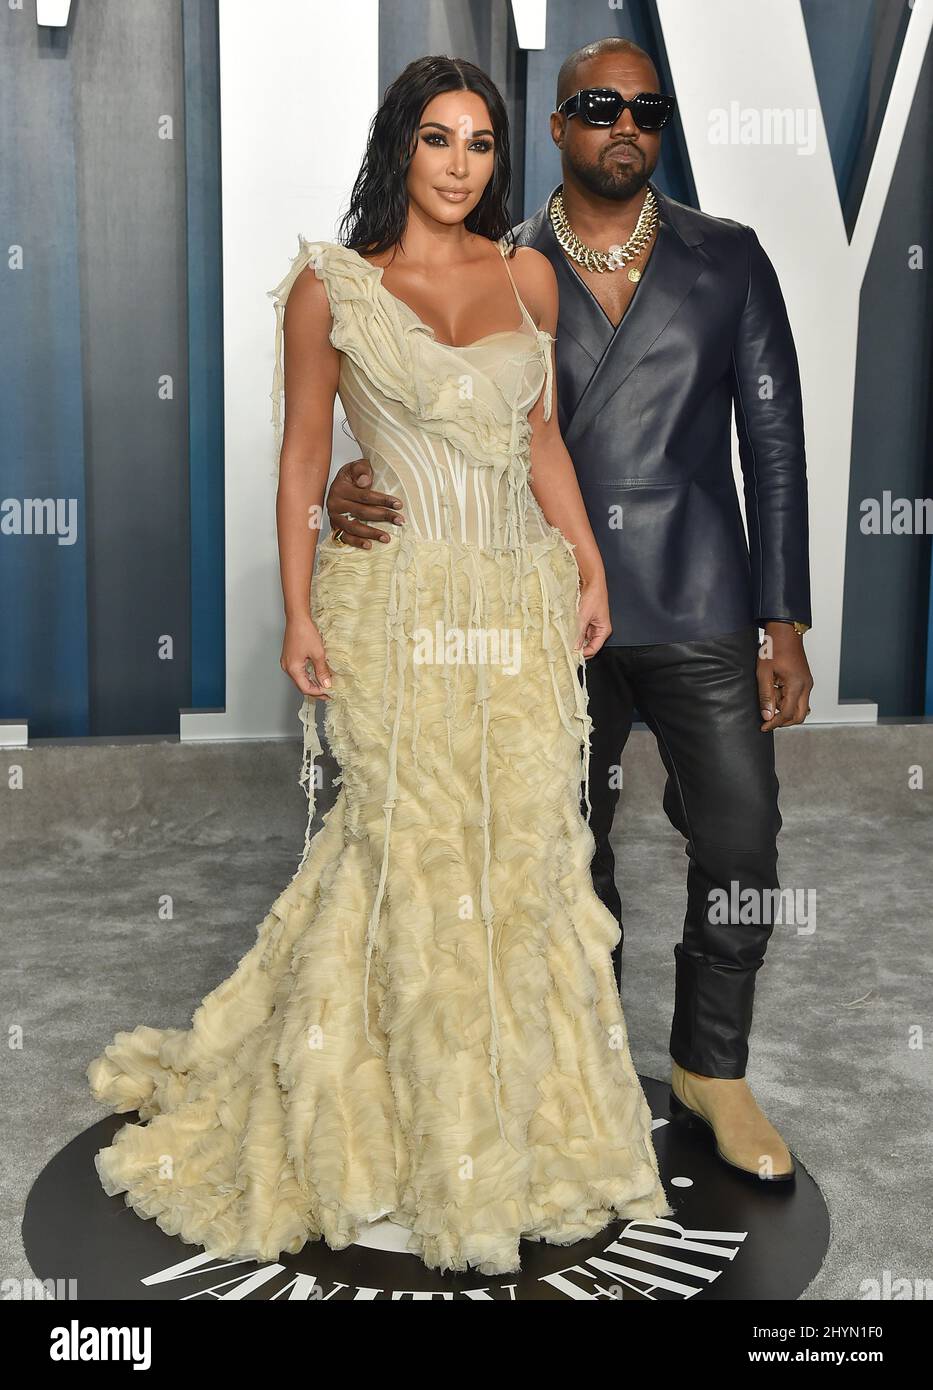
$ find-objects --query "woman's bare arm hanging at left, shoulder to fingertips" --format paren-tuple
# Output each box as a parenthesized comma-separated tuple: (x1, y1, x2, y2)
(275, 267, 339, 698)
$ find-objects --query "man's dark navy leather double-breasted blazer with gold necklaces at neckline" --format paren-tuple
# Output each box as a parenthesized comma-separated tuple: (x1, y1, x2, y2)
(514, 185, 811, 646)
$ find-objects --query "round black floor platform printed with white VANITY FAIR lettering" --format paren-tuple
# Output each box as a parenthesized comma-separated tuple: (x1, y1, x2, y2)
(22, 1077, 829, 1302)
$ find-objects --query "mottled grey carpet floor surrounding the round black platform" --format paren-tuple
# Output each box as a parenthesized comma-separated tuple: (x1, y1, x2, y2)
(0, 723, 933, 1300)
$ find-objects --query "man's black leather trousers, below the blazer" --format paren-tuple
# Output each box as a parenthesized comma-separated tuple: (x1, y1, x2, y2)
(587, 626, 781, 1077)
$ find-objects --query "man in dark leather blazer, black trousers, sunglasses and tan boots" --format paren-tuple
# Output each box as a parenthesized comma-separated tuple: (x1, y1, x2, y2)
(328, 39, 812, 1182)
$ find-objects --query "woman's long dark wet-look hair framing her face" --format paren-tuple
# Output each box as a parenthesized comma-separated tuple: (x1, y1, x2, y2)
(339, 57, 512, 256)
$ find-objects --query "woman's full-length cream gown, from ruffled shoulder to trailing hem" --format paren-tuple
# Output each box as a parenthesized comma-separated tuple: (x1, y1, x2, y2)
(88, 60, 672, 1275)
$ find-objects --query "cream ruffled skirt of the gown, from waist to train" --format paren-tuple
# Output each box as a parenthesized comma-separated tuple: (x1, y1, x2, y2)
(88, 537, 672, 1275)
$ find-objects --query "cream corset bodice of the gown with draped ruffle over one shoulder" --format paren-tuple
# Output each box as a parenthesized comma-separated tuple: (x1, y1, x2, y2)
(270, 236, 553, 552)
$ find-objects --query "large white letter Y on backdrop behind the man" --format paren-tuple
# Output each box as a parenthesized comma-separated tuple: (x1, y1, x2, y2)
(658, 0, 933, 721)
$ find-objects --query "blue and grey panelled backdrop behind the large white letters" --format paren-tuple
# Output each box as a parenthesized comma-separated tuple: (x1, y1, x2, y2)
(0, 0, 933, 738)
